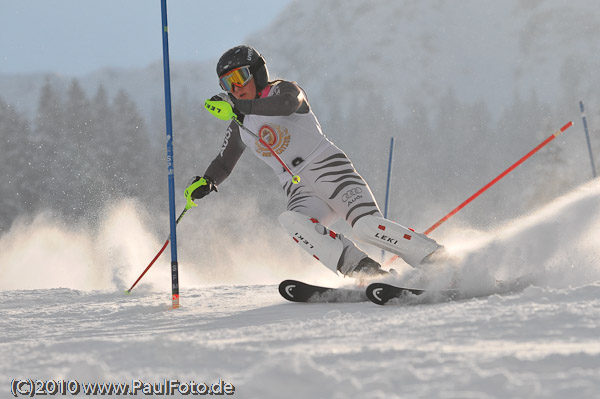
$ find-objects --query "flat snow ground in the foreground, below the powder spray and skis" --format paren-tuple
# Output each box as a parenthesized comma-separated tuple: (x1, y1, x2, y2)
(2, 284, 600, 398)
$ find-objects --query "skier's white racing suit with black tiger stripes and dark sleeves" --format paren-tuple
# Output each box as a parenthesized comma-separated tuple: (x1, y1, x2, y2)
(205, 81, 439, 274)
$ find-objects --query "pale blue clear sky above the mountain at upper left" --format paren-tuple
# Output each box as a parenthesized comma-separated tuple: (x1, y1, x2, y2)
(0, 0, 291, 76)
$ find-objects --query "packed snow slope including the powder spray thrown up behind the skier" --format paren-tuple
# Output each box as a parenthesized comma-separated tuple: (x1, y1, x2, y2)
(0, 180, 600, 398)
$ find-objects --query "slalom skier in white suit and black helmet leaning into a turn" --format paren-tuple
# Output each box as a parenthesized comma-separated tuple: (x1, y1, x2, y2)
(186, 45, 441, 277)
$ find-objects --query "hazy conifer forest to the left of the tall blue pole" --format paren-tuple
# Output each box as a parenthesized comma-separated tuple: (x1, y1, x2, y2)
(0, 79, 158, 232)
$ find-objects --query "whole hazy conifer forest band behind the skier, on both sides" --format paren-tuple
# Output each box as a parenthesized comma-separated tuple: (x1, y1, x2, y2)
(0, 72, 600, 238)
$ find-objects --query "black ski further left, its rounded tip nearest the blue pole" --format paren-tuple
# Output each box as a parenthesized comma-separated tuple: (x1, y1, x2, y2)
(279, 280, 367, 303)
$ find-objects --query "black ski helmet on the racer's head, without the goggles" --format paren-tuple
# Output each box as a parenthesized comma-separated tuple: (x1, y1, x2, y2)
(217, 45, 269, 92)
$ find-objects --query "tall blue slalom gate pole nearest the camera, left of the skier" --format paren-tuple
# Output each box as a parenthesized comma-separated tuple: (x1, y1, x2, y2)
(161, 0, 179, 309)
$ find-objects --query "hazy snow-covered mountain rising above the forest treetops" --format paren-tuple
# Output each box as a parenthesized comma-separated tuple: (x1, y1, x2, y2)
(5, 0, 600, 119)
